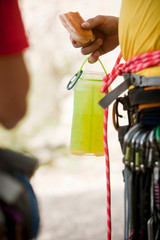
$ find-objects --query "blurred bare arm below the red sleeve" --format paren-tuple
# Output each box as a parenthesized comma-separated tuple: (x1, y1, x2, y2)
(0, 53, 29, 129)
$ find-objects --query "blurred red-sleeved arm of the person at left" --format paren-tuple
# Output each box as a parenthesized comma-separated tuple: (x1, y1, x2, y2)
(0, 0, 29, 129)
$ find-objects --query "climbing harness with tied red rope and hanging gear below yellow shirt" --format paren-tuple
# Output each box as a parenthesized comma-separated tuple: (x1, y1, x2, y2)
(99, 50, 160, 240)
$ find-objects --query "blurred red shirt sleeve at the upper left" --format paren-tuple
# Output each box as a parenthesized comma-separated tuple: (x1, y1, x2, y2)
(0, 0, 28, 55)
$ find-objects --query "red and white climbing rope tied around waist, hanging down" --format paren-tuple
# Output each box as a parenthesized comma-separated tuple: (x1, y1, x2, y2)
(101, 50, 160, 240)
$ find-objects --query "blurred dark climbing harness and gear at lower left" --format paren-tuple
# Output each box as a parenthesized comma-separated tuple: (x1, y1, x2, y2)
(0, 148, 40, 240)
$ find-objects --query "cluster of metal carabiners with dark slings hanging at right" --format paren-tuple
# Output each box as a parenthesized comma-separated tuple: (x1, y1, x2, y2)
(123, 123, 160, 240)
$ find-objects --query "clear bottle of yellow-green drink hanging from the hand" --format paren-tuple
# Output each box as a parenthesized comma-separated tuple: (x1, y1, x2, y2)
(67, 57, 106, 156)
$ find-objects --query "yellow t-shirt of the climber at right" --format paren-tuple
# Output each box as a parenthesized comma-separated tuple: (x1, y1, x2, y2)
(119, 0, 160, 76)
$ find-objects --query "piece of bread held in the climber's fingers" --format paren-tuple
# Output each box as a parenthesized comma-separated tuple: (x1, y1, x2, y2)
(59, 12, 95, 45)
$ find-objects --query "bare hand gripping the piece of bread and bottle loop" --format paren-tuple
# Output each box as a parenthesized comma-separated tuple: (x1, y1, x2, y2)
(71, 15, 119, 63)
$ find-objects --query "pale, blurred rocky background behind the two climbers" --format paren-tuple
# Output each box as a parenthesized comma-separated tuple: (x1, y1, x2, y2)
(0, 0, 123, 240)
